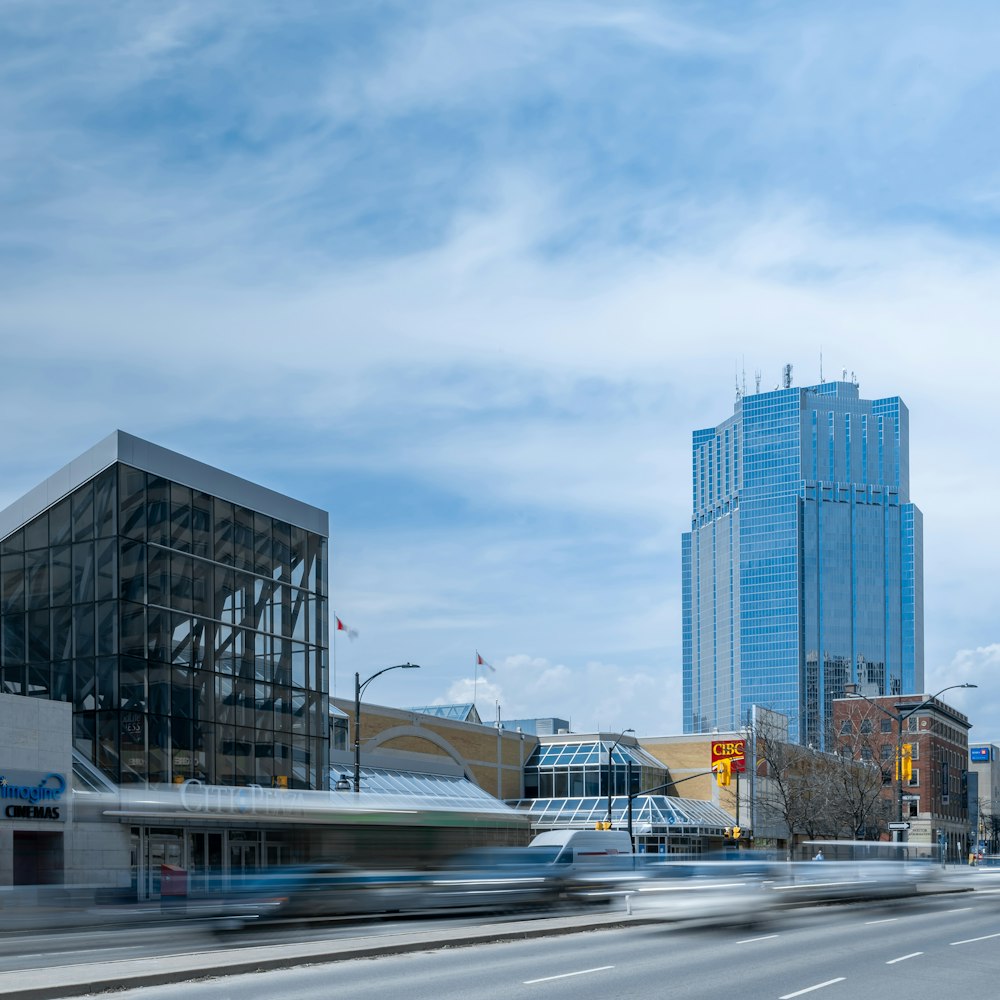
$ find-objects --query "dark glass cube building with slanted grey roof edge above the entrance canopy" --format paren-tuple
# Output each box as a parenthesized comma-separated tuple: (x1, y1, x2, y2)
(0, 431, 329, 789)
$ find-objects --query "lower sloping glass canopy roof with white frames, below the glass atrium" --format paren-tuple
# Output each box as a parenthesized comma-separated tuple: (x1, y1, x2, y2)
(508, 795, 733, 834)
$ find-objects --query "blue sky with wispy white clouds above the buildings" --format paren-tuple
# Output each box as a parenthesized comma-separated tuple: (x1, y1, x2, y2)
(0, 0, 1000, 739)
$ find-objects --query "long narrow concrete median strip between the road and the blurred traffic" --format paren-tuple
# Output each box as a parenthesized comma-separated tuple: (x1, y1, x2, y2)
(0, 907, 657, 1000)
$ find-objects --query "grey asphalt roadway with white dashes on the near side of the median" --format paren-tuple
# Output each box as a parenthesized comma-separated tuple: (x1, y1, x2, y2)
(45, 891, 1000, 1000)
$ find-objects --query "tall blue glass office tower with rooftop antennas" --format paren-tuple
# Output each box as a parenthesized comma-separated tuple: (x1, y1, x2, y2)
(682, 382, 923, 746)
